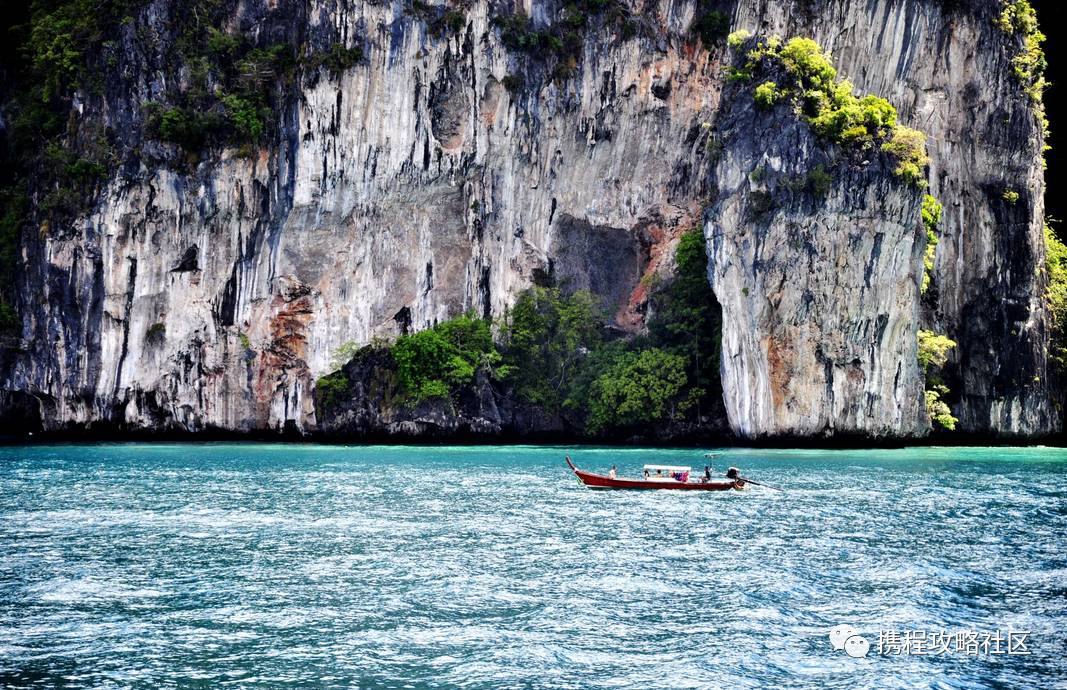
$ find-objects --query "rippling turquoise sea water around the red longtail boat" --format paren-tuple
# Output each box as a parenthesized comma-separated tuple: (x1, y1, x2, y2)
(0, 445, 1067, 689)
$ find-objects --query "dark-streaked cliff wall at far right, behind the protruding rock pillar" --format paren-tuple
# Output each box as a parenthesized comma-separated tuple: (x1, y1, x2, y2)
(734, 0, 1058, 435)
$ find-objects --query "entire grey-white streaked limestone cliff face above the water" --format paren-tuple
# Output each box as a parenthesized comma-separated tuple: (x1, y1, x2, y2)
(0, 0, 1056, 436)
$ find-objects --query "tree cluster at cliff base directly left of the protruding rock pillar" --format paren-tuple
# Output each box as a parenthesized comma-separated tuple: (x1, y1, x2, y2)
(503, 228, 721, 435)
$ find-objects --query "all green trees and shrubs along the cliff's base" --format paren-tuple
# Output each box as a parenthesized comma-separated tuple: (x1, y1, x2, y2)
(316, 229, 720, 435)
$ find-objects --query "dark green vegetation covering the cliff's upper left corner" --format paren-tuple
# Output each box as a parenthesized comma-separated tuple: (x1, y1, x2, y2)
(0, 0, 375, 332)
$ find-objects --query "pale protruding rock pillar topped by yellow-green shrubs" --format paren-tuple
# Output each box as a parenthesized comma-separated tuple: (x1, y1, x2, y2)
(704, 94, 927, 436)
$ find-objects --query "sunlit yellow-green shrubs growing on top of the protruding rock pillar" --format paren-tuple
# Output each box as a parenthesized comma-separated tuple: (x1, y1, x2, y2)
(728, 32, 929, 187)
